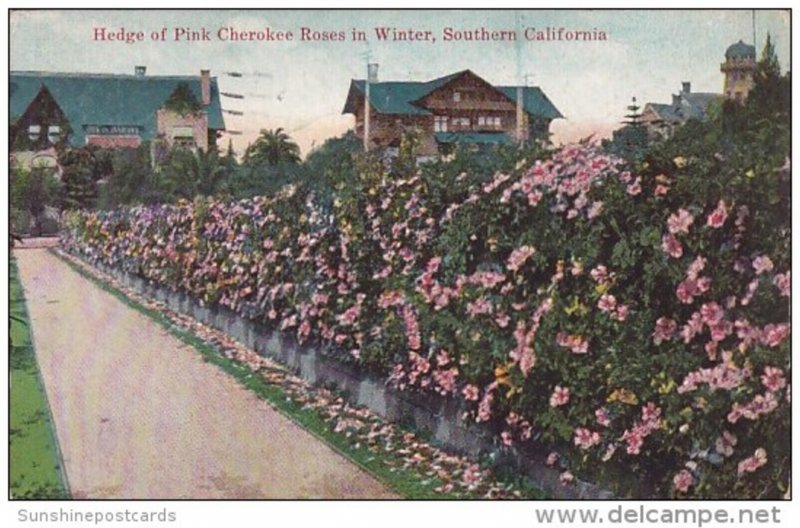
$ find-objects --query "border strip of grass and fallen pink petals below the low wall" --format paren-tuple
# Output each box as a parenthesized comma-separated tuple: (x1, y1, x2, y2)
(55, 250, 544, 499)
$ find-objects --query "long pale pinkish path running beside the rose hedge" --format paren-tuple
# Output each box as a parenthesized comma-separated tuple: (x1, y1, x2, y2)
(14, 249, 396, 499)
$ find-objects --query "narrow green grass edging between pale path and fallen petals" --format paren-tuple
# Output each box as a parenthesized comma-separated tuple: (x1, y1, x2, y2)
(51, 250, 545, 500)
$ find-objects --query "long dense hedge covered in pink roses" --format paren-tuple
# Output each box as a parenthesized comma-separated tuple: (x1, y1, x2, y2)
(62, 145, 791, 498)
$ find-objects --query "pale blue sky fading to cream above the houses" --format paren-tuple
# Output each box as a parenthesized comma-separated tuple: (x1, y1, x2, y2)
(9, 9, 790, 154)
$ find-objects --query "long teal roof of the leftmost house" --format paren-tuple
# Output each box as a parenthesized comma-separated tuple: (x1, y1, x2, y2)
(9, 72, 225, 146)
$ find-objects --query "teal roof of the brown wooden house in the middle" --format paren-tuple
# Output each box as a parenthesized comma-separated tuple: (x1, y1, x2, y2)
(342, 70, 564, 119)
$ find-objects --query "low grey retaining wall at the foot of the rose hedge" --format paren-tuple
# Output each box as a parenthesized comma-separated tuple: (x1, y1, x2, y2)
(76, 254, 613, 499)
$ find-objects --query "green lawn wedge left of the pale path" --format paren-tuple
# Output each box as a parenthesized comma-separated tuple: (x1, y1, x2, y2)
(9, 260, 68, 499)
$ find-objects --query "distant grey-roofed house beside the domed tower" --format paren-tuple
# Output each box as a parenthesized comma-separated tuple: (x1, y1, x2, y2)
(641, 82, 722, 140)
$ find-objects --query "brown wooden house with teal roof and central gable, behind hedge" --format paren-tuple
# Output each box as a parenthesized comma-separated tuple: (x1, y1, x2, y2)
(342, 70, 563, 156)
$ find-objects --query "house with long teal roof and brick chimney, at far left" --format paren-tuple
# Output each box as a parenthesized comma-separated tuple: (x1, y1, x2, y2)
(9, 66, 225, 157)
